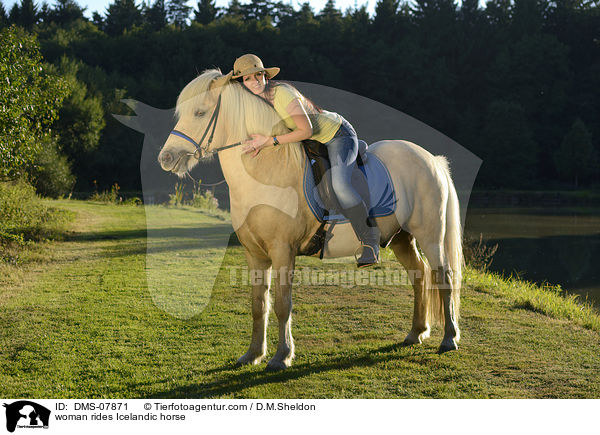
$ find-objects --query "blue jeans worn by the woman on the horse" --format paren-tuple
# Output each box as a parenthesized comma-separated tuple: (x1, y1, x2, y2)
(325, 118, 362, 209)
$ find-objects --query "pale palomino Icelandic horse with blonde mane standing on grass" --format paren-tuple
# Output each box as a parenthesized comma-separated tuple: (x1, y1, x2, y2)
(158, 70, 463, 369)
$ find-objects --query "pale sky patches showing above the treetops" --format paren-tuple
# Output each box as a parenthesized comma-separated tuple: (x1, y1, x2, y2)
(0, 0, 377, 18)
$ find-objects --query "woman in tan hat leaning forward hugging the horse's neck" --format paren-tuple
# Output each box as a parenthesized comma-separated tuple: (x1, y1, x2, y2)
(232, 54, 379, 267)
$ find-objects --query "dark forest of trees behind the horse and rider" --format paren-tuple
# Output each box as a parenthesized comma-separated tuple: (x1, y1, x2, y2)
(0, 0, 600, 197)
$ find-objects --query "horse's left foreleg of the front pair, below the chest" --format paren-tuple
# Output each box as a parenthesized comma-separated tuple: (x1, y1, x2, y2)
(237, 252, 271, 366)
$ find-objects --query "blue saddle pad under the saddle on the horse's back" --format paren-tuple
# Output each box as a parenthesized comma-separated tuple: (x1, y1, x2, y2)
(304, 153, 396, 223)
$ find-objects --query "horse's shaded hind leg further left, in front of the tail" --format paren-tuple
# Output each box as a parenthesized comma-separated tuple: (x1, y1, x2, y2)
(390, 231, 431, 346)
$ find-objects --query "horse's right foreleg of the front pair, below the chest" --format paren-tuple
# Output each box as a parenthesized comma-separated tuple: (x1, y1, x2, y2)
(267, 246, 295, 370)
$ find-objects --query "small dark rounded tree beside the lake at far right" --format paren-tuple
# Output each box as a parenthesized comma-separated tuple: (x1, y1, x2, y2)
(554, 118, 596, 186)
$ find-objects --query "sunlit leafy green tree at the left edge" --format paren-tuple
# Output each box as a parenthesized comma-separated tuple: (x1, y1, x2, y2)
(0, 26, 68, 180)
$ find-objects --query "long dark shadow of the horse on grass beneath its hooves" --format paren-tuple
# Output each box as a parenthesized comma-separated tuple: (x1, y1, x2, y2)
(152, 343, 422, 399)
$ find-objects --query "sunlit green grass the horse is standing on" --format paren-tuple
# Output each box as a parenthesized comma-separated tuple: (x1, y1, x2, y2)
(0, 201, 600, 398)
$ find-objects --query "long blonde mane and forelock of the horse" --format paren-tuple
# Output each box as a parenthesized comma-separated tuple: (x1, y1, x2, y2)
(175, 69, 304, 171)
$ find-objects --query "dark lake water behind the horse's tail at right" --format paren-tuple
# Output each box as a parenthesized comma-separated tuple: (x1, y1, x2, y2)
(465, 207, 600, 310)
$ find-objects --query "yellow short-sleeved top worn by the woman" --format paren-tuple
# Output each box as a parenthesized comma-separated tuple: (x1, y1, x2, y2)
(273, 84, 342, 143)
